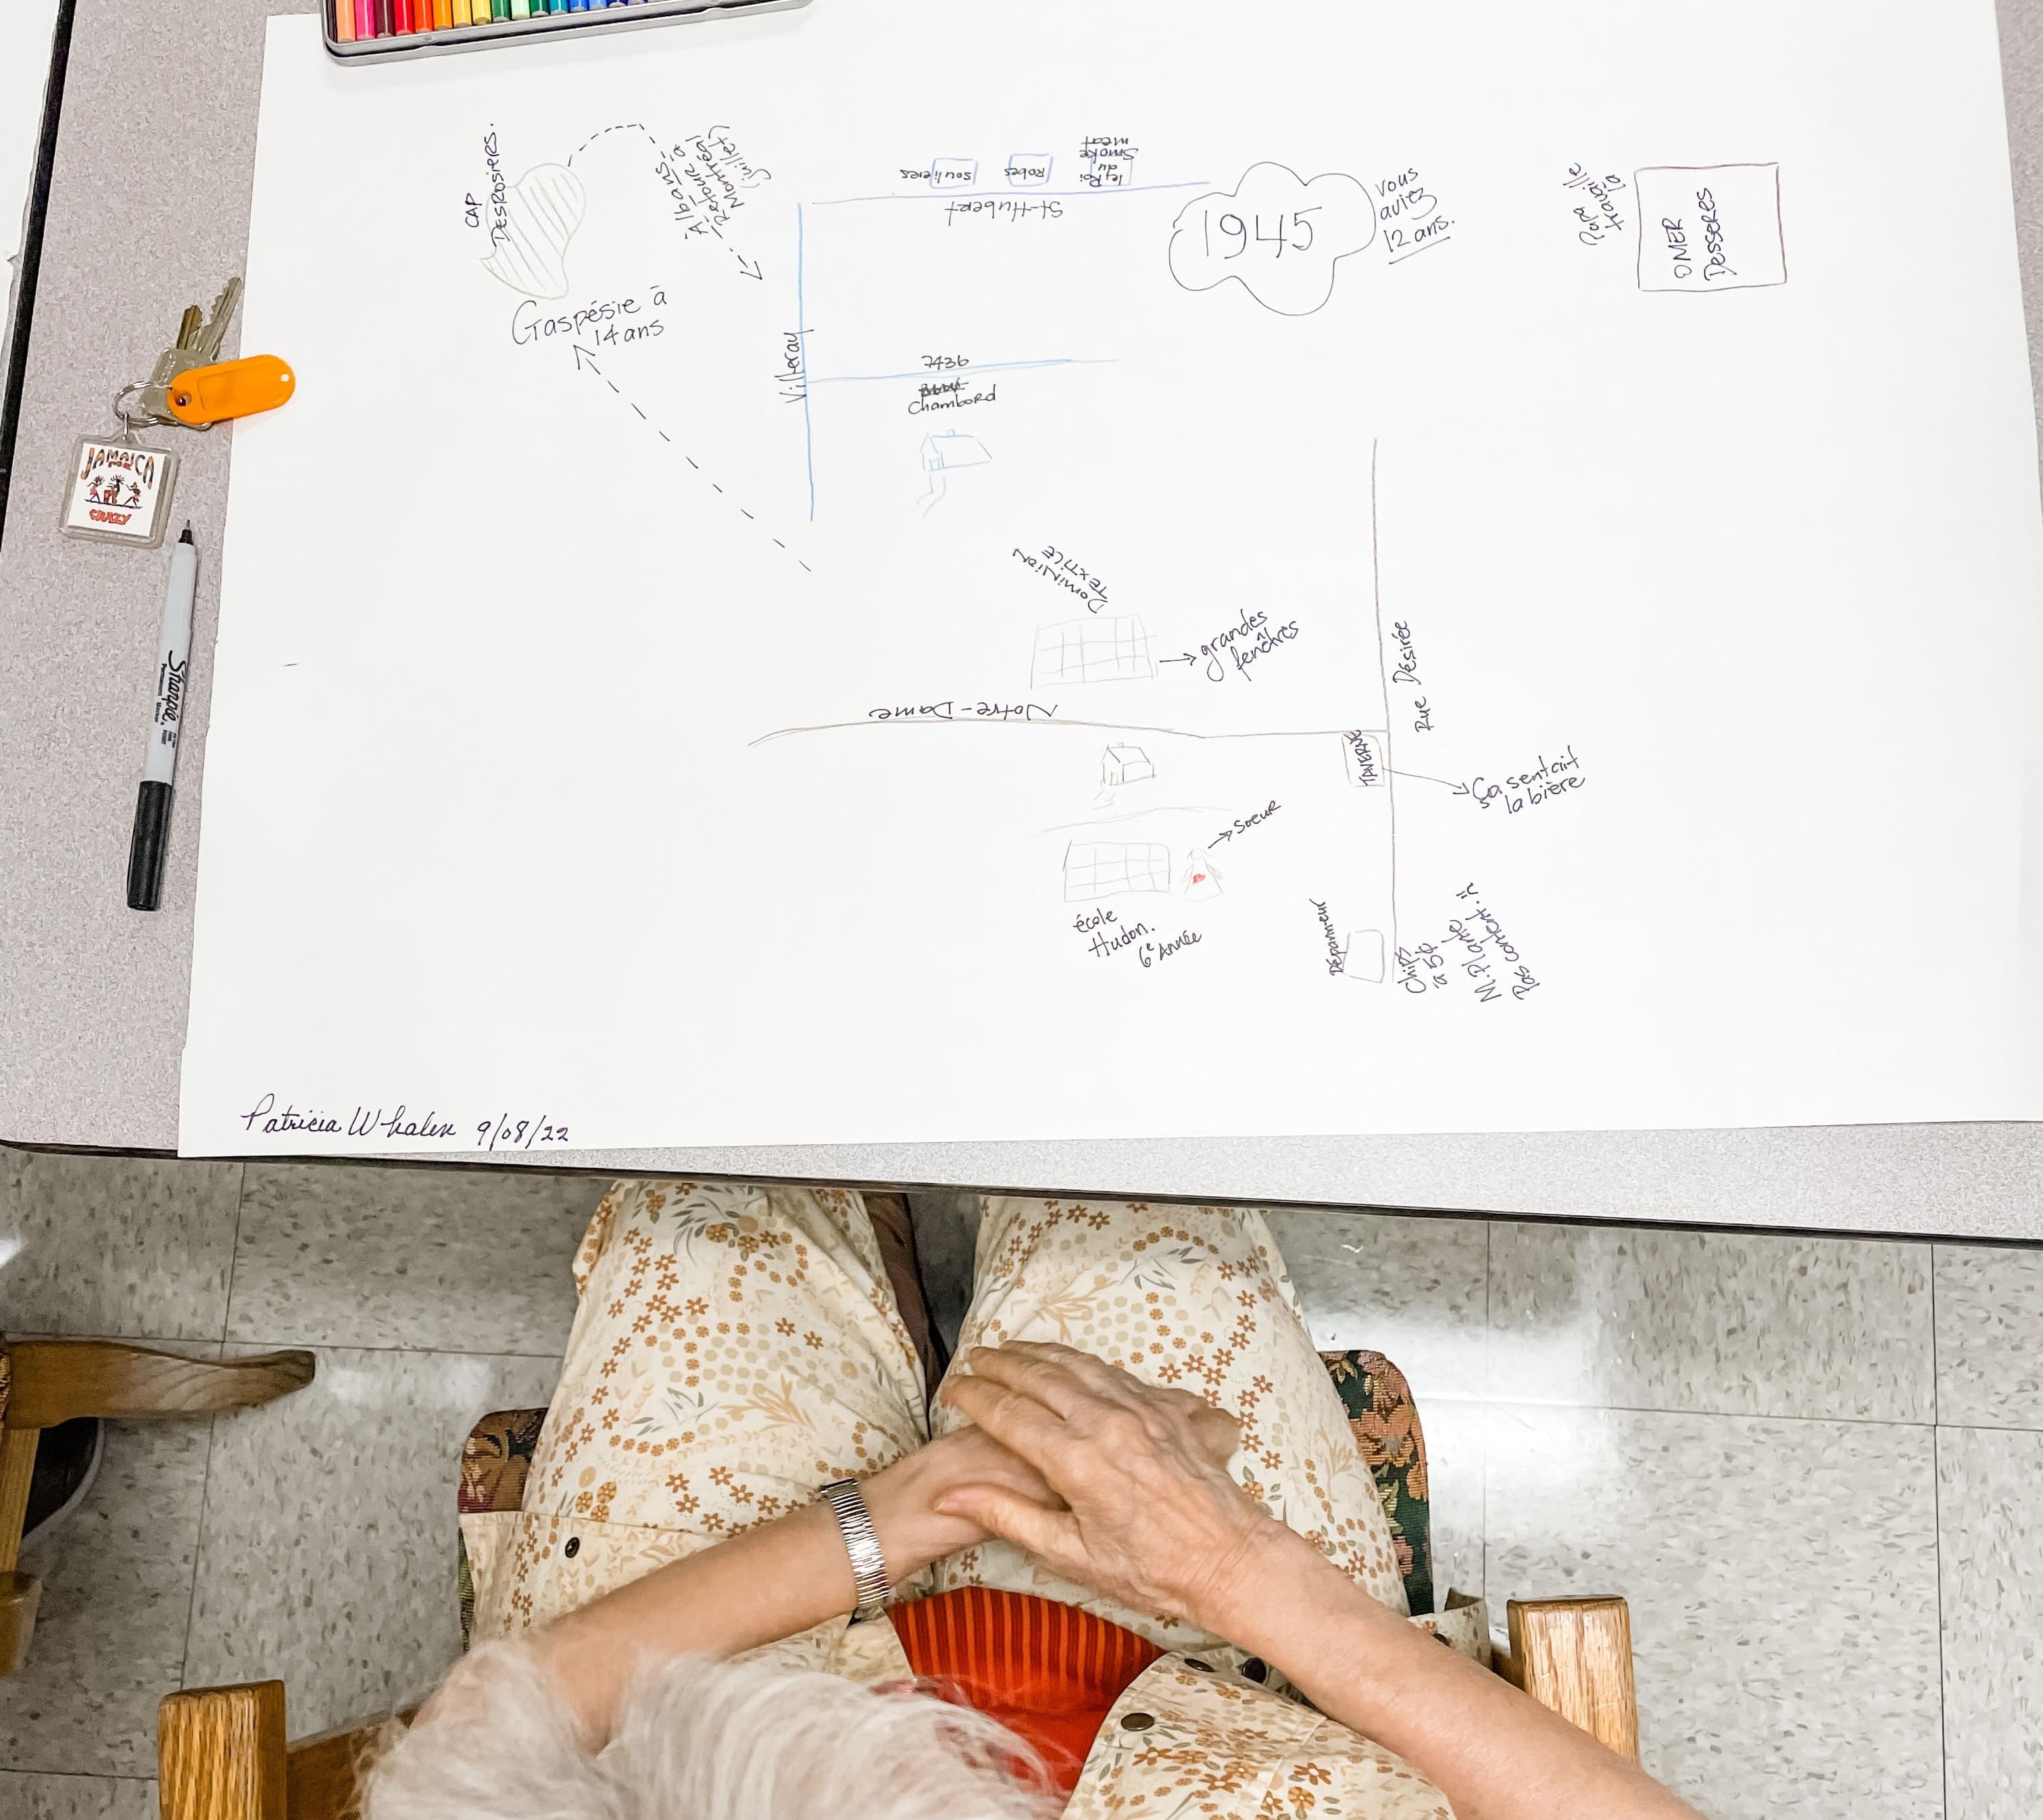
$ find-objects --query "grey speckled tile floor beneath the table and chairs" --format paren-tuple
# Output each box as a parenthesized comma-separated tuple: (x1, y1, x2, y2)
(0, 1152, 2043, 1820)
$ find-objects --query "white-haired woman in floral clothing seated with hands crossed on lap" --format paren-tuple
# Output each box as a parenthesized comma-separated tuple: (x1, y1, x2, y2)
(366, 1183, 1694, 1820)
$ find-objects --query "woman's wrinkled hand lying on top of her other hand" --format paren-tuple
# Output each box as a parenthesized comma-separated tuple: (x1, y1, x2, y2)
(936, 1342, 1324, 1634)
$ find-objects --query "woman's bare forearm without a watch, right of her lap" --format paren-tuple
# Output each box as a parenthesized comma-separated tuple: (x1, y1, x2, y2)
(1214, 1544, 1698, 1820)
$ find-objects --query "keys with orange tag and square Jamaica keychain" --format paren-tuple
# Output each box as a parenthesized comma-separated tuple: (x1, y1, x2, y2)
(57, 278, 298, 549)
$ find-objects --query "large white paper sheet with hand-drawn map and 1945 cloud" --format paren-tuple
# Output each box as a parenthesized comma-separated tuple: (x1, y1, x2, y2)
(182, 0, 2043, 1154)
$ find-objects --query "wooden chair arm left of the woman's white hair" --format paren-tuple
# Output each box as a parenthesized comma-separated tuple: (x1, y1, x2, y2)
(155, 1681, 390, 1820)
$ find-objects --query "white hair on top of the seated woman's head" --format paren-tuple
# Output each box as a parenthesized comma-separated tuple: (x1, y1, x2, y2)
(362, 1640, 1064, 1820)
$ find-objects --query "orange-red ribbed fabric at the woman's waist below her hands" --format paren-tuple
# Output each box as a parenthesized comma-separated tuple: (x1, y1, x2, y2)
(889, 1587, 1162, 1794)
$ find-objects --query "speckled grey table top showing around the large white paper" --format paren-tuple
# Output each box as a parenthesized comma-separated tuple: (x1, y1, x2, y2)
(0, 0, 2043, 1240)
